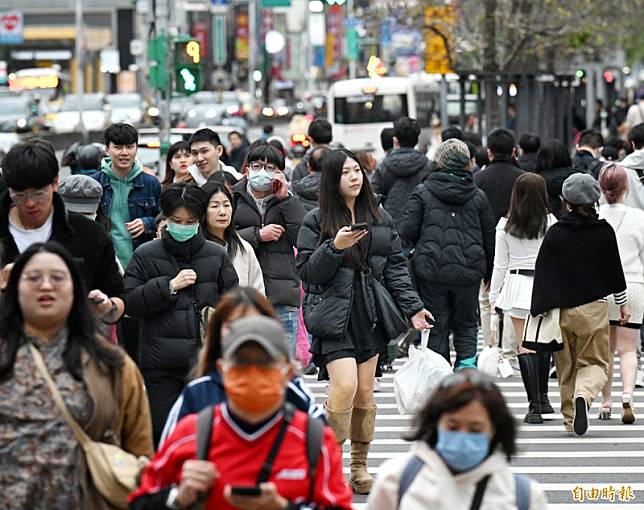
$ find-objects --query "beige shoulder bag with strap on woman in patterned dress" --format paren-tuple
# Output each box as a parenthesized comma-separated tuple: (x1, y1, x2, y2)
(29, 343, 141, 509)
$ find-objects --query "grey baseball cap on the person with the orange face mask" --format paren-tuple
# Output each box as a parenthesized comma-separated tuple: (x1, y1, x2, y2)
(222, 315, 291, 361)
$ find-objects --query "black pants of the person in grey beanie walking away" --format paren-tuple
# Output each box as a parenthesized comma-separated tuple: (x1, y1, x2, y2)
(417, 279, 479, 368)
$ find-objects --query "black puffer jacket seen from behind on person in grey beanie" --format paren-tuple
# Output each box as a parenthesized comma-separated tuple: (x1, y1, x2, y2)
(400, 170, 495, 285)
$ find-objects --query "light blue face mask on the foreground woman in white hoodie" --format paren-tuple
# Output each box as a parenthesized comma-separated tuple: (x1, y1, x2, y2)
(434, 428, 490, 471)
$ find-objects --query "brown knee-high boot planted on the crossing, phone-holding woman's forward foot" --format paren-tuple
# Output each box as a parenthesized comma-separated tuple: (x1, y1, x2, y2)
(349, 404, 376, 494)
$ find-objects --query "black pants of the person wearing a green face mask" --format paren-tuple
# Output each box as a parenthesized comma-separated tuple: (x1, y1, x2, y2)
(141, 369, 188, 449)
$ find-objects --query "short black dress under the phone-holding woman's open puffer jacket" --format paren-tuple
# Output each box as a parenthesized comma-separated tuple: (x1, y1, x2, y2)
(311, 271, 387, 381)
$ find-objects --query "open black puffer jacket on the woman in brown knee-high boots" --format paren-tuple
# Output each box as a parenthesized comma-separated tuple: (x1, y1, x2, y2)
(297, 205, 423, 338)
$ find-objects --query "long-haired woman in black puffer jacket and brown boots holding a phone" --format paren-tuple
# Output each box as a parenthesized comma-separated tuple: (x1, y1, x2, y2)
(297, 149, 432, 494)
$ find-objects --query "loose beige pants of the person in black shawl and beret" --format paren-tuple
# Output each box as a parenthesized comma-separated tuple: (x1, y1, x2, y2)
(555, 301, 610, 431)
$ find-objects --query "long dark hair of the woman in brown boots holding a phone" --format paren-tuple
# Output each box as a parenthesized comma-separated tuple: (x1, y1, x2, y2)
(320, 149, 380, 267)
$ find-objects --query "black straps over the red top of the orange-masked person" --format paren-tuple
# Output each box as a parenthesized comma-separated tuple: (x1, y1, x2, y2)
(196, 402, 324, 502)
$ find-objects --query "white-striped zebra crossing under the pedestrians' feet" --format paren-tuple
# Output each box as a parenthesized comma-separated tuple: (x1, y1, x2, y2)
(307, 352, 644, 510)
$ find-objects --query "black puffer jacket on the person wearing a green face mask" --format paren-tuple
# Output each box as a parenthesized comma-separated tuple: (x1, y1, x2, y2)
(125, 232, 238, 370)
